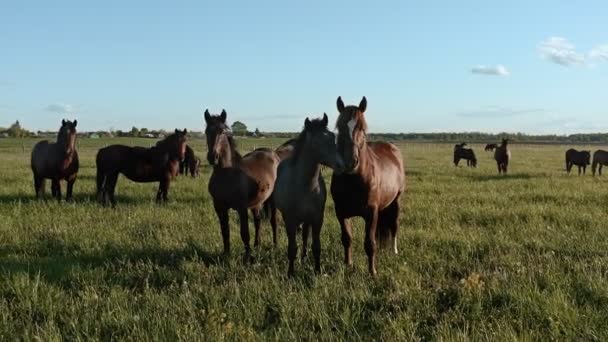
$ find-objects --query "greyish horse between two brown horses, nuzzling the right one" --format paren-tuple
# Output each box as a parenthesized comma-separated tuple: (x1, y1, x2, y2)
(273, 113, 342, 276)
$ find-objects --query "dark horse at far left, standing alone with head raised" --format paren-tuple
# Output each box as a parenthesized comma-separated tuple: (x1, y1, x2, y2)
(31, 120, 79, 201)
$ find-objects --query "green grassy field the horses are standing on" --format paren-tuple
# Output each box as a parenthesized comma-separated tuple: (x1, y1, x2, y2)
(0, 139, 608, 341)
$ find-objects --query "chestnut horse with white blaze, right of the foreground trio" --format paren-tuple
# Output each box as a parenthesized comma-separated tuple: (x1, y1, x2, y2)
(331, 97, 405, 276)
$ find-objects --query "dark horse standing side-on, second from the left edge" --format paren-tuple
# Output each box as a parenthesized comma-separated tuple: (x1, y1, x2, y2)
(96, 129, 188, 207)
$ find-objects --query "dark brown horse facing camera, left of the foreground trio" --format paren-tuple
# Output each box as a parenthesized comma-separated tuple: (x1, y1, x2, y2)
(205, 110, 280, 262)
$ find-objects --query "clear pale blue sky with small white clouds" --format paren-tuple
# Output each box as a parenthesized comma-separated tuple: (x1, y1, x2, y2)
(0, 0, 608, 134)
